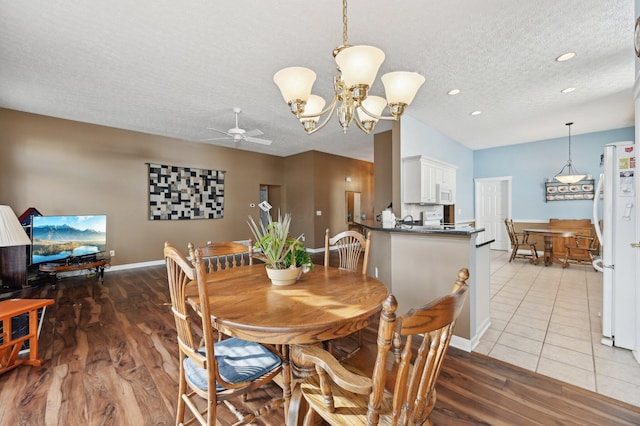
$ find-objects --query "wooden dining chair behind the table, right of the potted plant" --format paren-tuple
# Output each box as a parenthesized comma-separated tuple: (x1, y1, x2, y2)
(324, 228, 371, 358)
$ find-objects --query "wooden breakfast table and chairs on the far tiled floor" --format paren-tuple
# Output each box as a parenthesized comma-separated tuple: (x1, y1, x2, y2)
(505, 218, 600, 268)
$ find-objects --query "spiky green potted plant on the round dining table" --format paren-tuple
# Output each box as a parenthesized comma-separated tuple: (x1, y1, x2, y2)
(247, 212, 313, 285)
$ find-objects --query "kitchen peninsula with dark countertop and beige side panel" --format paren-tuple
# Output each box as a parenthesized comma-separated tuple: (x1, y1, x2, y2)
(359, 221, 493, 351)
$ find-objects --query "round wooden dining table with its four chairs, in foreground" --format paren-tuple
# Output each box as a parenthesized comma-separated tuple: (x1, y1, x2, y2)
(164, 231, 468, 425)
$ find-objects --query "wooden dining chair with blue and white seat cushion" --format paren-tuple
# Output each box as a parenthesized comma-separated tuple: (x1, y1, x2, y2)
(164, 242, 284, 425)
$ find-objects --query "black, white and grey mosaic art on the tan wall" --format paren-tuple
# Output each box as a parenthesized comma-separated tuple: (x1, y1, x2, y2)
(148, 164, 225, 220)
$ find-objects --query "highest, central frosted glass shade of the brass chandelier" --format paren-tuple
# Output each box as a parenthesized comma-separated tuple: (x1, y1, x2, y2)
(336, 46, 384, 88)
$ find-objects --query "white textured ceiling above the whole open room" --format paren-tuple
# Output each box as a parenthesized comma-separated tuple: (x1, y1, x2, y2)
(0, 0, 635, 161)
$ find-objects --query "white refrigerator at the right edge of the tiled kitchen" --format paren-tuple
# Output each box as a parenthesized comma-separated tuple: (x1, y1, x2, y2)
(593, 142, 640, 350)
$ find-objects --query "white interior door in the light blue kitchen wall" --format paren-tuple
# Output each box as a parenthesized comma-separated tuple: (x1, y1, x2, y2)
(475, 177, 511, 250)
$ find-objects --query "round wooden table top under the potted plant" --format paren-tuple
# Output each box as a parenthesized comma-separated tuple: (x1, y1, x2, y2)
(182, 264, 388, 344)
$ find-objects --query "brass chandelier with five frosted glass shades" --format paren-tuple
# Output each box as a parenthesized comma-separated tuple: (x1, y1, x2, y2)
(273, 0, 424, 134)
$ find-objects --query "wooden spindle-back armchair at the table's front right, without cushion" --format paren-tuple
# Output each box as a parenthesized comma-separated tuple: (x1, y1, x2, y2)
(288, 268, 469, 426)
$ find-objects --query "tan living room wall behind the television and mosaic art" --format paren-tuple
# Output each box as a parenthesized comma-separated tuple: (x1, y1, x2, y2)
(0, 108, 373, 265)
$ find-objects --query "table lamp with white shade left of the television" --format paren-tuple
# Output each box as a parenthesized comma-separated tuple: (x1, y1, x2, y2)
(0, 206, 31, 288)
